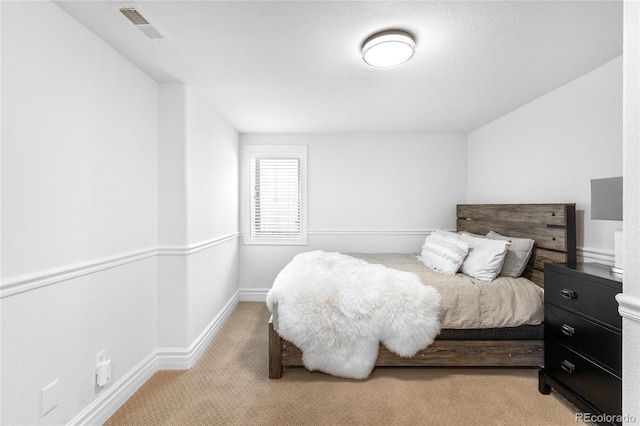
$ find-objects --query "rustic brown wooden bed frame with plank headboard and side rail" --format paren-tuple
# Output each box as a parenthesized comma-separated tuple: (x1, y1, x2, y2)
(269, 204, 576, 379)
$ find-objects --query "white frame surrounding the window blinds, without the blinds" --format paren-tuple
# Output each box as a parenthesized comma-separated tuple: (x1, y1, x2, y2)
(242, 145, 307, 246)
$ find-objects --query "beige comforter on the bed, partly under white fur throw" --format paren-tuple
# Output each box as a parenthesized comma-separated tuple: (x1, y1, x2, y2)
(350, 253, 544, 329)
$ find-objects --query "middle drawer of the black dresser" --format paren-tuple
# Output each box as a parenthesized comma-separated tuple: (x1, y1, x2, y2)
(544, 305, 622, 375)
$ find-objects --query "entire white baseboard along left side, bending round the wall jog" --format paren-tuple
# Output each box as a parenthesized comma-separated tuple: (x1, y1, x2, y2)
(68, 291, 240, 425)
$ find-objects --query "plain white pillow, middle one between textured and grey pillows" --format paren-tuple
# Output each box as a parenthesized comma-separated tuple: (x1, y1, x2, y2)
(460, 234, 511, 281)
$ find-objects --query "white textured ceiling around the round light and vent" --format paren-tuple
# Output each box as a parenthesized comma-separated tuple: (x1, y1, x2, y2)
(56, 1, 622, 133)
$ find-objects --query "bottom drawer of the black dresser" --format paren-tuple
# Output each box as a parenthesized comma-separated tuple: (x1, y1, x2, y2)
(544, 340, 622, 415)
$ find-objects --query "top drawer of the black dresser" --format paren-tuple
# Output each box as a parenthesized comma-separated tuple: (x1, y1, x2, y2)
(544, 271, 622, 329)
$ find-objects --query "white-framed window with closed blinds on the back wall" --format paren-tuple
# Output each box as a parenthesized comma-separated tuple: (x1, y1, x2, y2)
(243, 145, 307, 245)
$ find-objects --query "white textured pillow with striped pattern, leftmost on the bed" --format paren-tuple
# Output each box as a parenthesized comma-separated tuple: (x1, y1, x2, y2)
(420, 233, 469, 275)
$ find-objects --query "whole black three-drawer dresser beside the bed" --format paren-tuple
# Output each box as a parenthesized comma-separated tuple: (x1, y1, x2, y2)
(539, 263, 622, 424)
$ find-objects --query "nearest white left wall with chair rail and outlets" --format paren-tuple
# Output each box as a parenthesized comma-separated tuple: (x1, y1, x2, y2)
(1, 2, 158, 424)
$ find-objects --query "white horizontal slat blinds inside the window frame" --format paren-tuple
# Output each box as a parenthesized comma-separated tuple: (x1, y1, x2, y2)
(250, 158, 302, 239)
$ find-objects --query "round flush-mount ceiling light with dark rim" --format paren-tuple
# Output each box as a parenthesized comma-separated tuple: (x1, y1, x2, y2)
(362, 30, 416, 68)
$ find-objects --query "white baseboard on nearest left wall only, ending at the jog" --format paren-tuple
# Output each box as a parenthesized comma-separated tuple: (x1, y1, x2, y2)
(68, 351, 158, 425)
